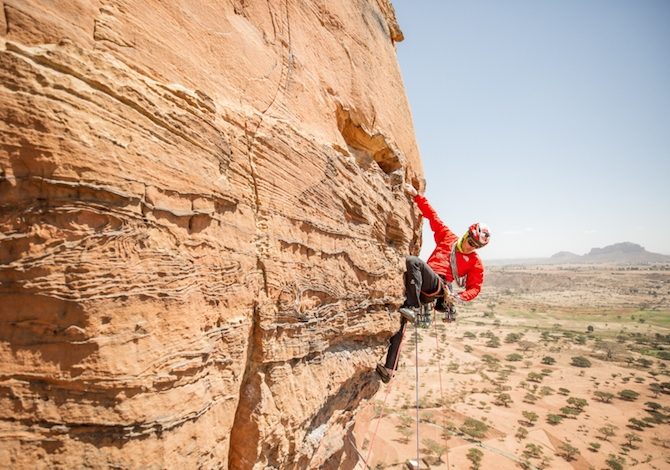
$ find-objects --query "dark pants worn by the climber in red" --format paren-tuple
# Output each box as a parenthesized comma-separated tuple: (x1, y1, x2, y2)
(385, 256, 442, 370)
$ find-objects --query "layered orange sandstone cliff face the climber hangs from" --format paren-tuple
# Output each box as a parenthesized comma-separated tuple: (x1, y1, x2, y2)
(0, 0, 423, 469)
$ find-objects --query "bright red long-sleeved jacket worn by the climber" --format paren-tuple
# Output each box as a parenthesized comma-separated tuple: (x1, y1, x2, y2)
(414, 194, 484, 301)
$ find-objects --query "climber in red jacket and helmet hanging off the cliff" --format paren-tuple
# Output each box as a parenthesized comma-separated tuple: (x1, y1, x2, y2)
(377, 184, 490, 383)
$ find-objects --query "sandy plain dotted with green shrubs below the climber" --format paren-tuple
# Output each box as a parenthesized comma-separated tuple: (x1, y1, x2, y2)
(353, 266, 670, 470)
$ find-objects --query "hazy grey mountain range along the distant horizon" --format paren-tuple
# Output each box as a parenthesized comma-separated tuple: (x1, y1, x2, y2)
(486, 242, 670, 266)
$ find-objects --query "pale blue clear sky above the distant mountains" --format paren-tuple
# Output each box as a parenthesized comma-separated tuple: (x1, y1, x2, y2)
(393, 0, 670, 260)
